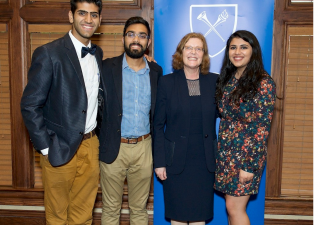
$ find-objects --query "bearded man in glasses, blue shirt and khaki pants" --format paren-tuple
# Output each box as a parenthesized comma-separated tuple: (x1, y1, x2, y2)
(99, 17, 162, 225)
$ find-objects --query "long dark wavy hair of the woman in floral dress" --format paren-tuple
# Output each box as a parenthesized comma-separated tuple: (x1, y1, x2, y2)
(216, 30, 272, 105)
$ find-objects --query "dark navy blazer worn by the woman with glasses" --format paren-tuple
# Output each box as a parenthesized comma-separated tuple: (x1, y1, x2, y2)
(153, 70, 218, 174)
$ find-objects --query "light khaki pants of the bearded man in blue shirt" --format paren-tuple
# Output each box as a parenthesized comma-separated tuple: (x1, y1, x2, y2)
(100, 136, 152, 225)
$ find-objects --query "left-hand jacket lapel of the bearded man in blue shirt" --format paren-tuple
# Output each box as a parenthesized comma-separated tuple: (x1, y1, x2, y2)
(112, 54, 123, 109)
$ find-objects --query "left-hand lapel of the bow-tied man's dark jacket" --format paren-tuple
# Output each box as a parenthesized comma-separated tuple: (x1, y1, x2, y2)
(64, 33, 86, 90)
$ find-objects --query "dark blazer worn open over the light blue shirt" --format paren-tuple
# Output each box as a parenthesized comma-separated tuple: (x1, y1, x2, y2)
(99, 54, 163, 163)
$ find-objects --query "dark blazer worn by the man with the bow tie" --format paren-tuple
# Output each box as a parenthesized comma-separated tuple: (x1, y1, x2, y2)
(21, 34, 103, 166)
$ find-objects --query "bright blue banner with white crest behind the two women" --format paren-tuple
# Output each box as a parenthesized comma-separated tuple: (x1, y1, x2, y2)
(153, 0, 274, 225)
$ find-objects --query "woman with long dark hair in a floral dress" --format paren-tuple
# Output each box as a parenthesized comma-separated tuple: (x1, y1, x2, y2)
(214, 30, 276, 225)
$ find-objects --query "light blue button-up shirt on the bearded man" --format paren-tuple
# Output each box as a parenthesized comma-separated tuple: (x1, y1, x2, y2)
(121, 54, 151, 138)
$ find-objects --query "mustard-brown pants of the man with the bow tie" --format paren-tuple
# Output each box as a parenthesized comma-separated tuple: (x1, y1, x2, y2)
(40, 136, 99, 225)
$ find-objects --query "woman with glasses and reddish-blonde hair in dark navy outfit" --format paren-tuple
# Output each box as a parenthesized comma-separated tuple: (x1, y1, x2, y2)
(153, 33, 218, 225)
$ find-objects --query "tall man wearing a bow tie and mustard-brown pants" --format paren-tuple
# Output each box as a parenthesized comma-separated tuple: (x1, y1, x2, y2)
(21, 0, 103, 225)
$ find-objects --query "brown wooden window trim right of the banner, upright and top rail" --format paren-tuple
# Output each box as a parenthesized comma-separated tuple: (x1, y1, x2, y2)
(266, 0, 313, 197)
